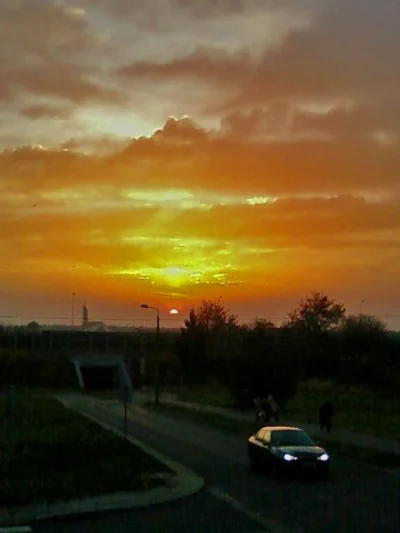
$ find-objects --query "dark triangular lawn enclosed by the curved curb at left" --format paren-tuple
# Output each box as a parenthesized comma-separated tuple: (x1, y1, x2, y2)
(0, 386, 173, 507)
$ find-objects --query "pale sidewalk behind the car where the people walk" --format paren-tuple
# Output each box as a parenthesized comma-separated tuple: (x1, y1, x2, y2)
(150, 393, 400, 458)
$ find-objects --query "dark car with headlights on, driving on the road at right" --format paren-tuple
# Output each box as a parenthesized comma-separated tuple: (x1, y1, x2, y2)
(248, 426, 330, 478)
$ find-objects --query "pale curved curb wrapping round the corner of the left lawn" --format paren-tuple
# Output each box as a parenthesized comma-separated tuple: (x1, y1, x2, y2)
(0, 398, 204, 533)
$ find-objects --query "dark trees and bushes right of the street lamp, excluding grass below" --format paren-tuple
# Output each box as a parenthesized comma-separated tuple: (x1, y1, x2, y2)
(175, 292, 400, 403)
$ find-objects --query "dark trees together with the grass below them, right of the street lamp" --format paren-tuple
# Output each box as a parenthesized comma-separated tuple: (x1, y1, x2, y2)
(160, 293, 400, 440)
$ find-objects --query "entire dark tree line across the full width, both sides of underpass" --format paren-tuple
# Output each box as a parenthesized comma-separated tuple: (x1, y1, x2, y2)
(0, 293, 400, 404)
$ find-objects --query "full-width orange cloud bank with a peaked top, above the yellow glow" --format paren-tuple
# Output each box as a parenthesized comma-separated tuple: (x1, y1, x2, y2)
(0, 119, 400, 196)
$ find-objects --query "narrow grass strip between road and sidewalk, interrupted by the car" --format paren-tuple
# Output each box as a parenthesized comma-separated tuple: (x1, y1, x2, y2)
(144, 403, 400, 468)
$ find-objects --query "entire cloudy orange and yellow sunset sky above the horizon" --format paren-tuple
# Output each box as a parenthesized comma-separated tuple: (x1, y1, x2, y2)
(0, 0, 400, 328)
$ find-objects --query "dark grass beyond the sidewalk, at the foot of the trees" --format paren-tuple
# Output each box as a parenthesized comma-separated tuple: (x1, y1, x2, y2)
(165, 381, 400, 440)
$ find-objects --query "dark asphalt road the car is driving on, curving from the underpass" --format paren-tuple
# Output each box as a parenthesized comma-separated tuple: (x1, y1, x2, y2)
(34, 400, 400, 533)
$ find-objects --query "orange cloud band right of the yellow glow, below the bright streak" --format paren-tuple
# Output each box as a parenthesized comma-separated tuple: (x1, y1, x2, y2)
(166, 196, 400, 247)
